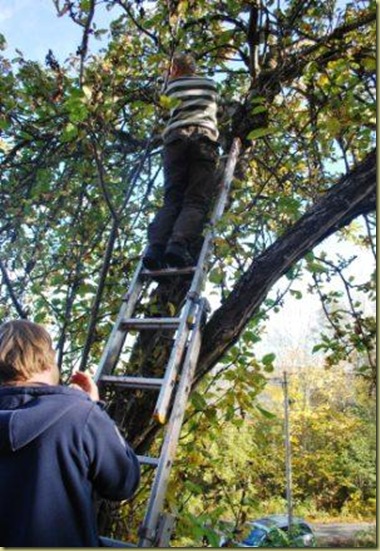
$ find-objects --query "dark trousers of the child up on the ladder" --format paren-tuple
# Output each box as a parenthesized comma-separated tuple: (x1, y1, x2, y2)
(148, 126, 218, 254)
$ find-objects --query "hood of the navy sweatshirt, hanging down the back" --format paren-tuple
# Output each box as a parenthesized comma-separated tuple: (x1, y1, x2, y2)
(0, 385, 91, 453)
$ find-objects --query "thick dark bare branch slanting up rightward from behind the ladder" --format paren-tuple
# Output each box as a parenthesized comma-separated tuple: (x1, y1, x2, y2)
(196, 150, 376, 382)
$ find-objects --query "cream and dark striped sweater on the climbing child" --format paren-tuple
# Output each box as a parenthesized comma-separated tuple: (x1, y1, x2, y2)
(163, 76, 219, 140)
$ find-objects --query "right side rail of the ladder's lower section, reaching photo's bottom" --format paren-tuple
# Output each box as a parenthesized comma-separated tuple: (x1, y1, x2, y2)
(139, 300, 205, 547)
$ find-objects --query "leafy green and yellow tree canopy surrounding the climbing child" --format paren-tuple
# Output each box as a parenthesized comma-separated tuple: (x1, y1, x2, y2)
(0, 0, 376, 540)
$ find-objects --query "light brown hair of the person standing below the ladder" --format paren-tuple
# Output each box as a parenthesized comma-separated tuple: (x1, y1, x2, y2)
(0, 320, 56, 384)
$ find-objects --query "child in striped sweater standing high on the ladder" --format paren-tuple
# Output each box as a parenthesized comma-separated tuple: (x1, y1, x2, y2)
(143, 54, 219, 270)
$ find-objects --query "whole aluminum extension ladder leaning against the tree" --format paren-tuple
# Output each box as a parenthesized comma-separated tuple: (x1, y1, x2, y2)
(94, 138, 241, 547)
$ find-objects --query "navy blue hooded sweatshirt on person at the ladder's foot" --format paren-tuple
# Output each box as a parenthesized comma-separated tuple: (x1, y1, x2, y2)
(0, 385, 140, 547)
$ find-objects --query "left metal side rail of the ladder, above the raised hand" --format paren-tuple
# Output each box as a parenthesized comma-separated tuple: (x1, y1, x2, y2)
(94, 259, 143, 382)
